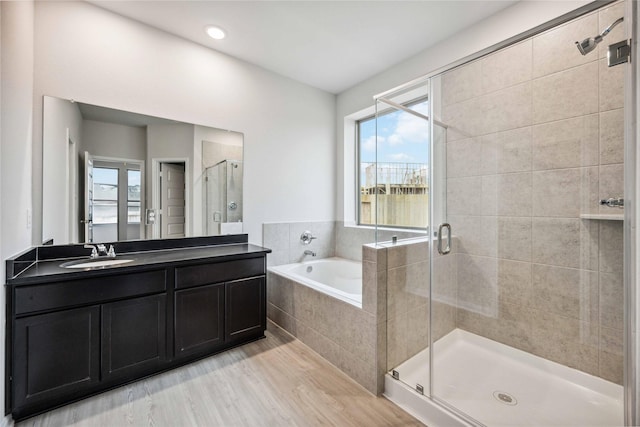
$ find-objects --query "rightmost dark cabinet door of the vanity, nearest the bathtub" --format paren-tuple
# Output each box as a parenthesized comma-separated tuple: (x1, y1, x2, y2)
(226, 277, 267, 341)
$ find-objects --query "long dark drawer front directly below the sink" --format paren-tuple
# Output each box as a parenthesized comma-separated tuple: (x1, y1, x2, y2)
(15, 269, 167, 315)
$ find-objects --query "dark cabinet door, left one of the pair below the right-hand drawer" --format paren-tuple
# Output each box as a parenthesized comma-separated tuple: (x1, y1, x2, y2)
(175, 283, 224, 357)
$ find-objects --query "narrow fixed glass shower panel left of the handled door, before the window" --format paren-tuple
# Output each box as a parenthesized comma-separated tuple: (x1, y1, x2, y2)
(376, 82, 432, 402)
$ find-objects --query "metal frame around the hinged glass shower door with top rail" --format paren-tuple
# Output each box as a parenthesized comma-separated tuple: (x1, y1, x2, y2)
(373, 0, 640, 425)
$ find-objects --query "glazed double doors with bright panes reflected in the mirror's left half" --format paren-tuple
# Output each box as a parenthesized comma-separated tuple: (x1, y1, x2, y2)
(83, 153, 145, 242)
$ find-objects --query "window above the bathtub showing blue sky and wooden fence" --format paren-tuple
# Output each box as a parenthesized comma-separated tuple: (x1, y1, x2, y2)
(356, 98, 429, 228)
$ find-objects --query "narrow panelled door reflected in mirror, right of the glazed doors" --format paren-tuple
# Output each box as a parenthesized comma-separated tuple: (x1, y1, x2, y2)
(160, 163, 186, 239)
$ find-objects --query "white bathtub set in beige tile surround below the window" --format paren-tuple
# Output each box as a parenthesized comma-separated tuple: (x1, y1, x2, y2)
(269, 258, 362, 308)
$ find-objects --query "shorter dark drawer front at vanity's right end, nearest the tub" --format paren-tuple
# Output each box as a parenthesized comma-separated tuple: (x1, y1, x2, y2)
(176, 257, 265, 289)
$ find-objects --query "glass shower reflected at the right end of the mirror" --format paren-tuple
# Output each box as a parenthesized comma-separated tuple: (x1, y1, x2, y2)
(205, 159, 242, 235)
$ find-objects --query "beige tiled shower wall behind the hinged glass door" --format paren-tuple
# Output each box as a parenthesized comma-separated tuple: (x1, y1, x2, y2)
(440, 4, 624, 383)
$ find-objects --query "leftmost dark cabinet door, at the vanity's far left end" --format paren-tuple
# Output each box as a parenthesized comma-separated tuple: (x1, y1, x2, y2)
(12, 306, 100, 410)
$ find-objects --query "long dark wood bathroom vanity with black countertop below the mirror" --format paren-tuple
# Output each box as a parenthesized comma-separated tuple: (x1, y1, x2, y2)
(5, 235, 270, 420)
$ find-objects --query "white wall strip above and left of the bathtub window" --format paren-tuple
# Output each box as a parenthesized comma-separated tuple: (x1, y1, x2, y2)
(336, 1, 590, 223)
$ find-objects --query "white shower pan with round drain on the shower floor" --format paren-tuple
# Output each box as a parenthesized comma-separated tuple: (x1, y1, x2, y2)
(385, 329, 624, 427)
